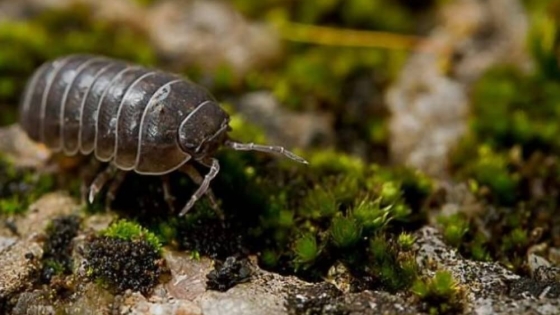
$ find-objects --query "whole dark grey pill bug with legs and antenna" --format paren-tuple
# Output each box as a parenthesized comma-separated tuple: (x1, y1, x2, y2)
(19, 54, 307, 216)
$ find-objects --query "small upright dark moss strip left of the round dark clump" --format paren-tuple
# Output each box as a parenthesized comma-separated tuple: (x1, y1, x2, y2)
(41, 215, 81, 283)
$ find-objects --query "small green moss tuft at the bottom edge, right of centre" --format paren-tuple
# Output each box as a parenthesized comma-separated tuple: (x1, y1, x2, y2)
(411, 270, 465, 315)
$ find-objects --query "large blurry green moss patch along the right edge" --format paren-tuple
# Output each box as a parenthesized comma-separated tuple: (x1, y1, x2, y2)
(440, 1, 560, 275)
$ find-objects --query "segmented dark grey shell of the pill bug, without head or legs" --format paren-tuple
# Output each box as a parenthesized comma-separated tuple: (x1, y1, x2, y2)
(20, 54, 219, 175)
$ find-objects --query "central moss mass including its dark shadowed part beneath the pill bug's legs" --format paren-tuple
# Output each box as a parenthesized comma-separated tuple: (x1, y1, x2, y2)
(112, 130, 432, 290)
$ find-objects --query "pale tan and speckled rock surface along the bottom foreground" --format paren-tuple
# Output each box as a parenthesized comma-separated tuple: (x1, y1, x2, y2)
(0, 183, 560, 315)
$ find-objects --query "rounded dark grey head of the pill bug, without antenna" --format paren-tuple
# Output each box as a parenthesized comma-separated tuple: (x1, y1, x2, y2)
(178, 101, 231, 160)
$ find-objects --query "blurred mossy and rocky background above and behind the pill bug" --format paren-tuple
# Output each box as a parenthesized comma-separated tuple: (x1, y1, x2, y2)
(0, 0, 548, 178)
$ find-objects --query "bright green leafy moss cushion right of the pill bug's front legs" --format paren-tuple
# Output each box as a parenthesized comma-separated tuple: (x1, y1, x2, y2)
(207, 147, 432, 288)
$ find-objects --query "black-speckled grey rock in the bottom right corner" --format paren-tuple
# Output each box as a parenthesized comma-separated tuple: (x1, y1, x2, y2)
(416, 227, 560, 315)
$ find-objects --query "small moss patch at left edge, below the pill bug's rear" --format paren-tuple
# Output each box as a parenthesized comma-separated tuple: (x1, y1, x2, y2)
(0, 155, 55, 215)
